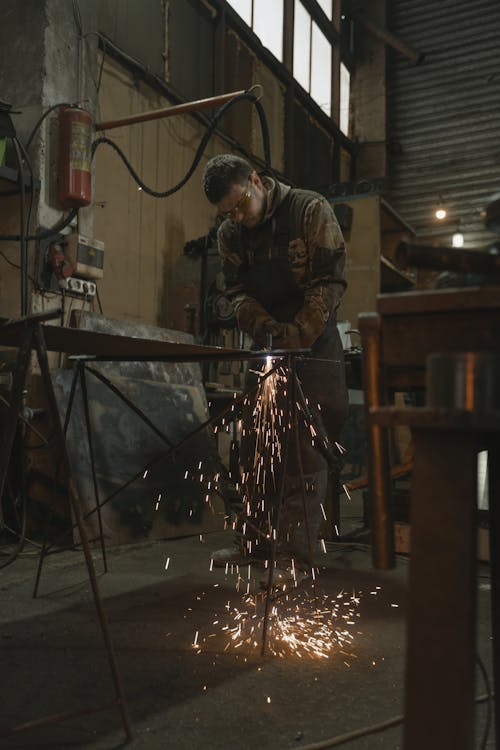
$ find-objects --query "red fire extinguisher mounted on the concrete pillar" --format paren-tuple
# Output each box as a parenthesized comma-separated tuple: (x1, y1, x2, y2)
(59, 107, 92, 208)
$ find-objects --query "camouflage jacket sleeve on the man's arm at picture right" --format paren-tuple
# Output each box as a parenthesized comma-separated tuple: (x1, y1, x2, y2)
(293, 198, 347, 347)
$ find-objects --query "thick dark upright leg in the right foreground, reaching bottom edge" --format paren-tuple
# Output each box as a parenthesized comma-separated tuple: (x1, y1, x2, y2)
(404, 428, 477, 750)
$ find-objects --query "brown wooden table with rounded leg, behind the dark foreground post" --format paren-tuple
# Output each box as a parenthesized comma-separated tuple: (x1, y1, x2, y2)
(358, 286, 500, 569)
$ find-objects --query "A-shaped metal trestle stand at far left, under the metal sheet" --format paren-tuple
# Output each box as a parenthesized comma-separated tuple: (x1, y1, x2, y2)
(0, 313, 132, 739)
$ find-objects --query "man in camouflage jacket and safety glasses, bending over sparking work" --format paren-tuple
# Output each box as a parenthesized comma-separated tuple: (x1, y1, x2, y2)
(203, 154, 347, 580)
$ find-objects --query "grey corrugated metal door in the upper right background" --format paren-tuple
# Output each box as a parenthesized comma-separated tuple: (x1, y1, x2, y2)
(387, 0, 500, 253)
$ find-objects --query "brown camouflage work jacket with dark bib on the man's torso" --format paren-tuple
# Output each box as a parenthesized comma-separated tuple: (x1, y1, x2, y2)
(218, 177, 346, 348)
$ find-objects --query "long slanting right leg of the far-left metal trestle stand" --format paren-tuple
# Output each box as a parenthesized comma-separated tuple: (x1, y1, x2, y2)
(33, 324, 132, 739)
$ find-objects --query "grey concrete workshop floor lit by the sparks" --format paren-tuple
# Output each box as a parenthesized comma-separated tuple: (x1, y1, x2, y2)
(0, 500, 495, 750)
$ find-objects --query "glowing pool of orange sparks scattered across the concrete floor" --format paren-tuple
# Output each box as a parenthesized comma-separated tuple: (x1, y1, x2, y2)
(193, 589, 360, 666)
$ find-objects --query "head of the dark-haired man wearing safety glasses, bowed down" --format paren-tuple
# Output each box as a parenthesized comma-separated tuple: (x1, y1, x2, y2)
(203, 154, 266, 227)
